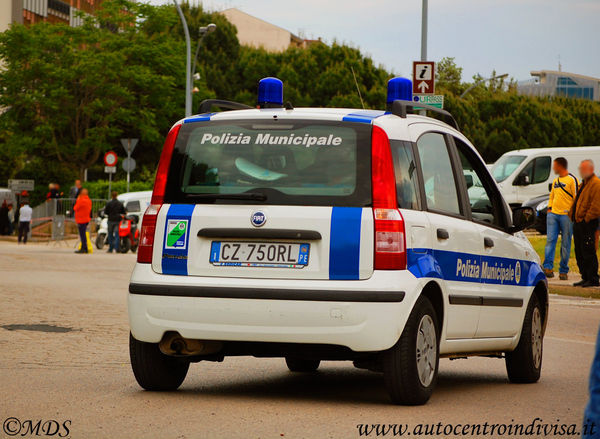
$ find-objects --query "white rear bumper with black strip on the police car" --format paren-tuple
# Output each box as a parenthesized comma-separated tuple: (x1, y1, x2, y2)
(128, 264, 420, 352)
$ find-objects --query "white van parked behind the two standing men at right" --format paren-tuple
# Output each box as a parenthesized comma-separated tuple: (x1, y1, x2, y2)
(491, 146, 600, 206)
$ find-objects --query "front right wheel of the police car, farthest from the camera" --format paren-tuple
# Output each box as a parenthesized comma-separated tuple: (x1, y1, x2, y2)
(506, 294, 544, 383)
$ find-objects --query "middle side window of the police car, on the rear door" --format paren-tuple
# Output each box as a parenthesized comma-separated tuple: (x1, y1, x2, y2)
(417, 133, 461, 215)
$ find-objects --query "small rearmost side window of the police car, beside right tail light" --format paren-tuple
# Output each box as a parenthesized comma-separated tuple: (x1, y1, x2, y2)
(391, 140, 420, 210)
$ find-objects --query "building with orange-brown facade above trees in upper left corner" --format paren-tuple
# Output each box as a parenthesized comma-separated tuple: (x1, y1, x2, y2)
(0, 0, 102, 32)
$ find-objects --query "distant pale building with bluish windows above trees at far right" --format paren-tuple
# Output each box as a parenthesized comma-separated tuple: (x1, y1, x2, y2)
(517, 70, 600, 102)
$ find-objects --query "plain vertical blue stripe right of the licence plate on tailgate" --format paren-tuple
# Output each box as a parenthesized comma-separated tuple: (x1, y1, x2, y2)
(329, 207, 362, 280)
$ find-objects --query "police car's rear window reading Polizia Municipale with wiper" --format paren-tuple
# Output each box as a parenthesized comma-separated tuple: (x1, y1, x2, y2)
(166, 119, 371, 206)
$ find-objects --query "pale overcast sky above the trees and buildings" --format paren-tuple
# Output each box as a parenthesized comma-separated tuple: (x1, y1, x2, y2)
(149, 0, 600, 80)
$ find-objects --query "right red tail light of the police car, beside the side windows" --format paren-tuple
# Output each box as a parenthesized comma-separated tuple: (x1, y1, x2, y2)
(371, 126, 406, 270)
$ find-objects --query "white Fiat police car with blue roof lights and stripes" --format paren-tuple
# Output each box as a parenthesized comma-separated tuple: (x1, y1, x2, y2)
(128, 78, 548, 404)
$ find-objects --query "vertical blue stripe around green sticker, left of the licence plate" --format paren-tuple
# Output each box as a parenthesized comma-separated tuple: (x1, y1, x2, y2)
(162, 204, 195, 276)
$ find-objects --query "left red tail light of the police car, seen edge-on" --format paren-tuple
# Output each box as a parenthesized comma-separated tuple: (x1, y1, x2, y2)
(137, 125, 181, 264)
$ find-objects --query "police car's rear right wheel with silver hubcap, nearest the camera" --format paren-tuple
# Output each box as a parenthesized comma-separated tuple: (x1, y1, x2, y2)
(382, 296, 440, 405)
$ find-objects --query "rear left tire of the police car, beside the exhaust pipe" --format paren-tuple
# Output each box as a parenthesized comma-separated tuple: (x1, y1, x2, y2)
(129, 333, 190, 391)
